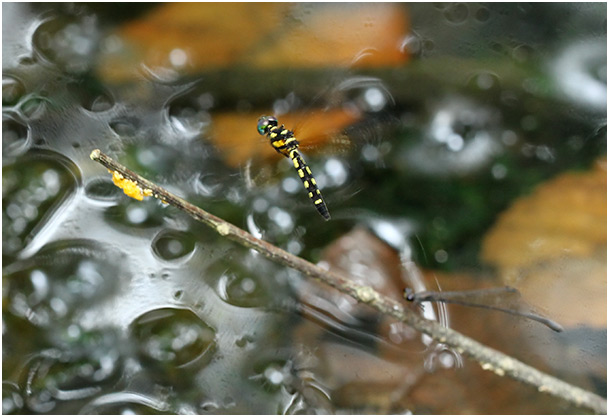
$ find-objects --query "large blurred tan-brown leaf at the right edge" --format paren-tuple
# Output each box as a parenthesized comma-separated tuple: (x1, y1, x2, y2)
(482, 159, 607, 326)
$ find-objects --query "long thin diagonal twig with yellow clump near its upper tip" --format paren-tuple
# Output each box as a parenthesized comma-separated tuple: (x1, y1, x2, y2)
(90, 149, 607, 414)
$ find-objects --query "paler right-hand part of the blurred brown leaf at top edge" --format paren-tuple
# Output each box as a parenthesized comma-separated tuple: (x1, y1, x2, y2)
(243, 3, 408, 68)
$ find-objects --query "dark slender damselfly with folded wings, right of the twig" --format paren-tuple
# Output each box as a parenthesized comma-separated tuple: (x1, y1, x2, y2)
(404, 286, 564, 332)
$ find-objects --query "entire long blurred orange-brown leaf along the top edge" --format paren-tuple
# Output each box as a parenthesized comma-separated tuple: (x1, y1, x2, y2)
(100, 3, 408, 82)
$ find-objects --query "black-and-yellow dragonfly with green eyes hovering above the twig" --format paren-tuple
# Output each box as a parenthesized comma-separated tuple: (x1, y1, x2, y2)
(258, 116, 330, 220)
